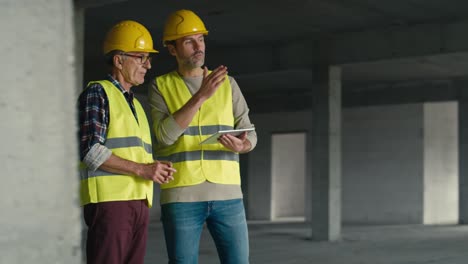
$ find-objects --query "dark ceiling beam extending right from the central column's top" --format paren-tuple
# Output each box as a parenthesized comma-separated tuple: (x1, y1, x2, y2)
(332, 21, 468, 65)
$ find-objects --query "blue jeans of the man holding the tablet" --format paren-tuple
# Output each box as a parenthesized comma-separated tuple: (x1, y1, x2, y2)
(161, 199, 249, 264)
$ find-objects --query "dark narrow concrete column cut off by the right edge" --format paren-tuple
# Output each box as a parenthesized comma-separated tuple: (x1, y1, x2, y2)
(456, 81, 468, 224)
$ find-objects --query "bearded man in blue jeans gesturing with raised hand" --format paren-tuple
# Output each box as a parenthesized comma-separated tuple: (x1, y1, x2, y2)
(149, 10, 257, 264)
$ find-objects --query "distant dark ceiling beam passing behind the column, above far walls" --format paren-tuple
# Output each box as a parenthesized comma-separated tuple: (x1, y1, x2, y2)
(244, 79, 468, 114)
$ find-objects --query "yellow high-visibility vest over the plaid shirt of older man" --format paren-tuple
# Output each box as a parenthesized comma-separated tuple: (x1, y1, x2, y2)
(80, 80, 154, 207)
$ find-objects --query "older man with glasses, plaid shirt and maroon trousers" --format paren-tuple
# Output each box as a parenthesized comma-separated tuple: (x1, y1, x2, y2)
(78, 20, 175, 264)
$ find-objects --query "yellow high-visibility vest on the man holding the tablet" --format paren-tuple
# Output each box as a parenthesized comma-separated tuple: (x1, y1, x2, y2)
(155, 71, 240, 189)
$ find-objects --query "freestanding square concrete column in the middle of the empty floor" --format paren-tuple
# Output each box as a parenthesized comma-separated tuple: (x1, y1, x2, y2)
(307, 64, 341, 241)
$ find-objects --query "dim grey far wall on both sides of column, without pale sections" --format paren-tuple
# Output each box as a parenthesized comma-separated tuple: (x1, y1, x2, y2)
(248, 104, 430, 224)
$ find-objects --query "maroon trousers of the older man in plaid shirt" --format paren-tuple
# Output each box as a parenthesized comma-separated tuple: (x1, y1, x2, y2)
(84, 200, 149, 264)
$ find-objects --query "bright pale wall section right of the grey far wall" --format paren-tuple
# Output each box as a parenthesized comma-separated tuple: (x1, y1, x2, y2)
(423, 102, 458, 224)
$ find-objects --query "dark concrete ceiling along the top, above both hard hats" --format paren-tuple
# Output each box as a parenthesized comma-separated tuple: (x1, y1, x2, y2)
(83, 0, 468, 45)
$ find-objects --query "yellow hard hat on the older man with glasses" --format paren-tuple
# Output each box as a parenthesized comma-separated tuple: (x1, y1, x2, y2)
(103, 20, 158, 54)
